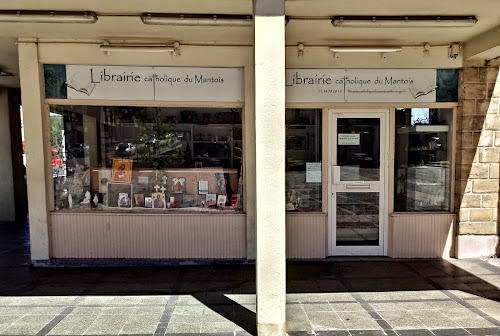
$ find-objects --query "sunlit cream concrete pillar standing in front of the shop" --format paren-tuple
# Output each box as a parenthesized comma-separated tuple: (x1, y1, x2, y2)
(254, 0, 286, 336)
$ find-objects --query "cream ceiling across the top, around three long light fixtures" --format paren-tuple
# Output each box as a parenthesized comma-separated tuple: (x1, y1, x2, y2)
(0, 0, 500, 86)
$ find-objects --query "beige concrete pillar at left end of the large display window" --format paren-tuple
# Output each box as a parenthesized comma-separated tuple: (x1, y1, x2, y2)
(19, 41, 53, 260)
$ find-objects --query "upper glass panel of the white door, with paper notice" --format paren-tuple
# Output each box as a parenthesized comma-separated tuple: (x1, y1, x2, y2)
(337, 118, 380, 181)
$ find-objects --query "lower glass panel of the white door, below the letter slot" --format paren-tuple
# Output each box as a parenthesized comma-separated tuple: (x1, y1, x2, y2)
(336, 192, 379, 246)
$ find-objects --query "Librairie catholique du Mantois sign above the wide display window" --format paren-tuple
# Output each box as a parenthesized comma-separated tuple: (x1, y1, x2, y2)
(44, 65, 245, 102)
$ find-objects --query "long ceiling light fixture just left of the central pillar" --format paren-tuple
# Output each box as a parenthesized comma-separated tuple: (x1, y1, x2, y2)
(141, 13, 253, 27)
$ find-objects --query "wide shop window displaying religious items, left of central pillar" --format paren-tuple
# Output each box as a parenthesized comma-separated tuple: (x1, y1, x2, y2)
(50, 105, 243, 212)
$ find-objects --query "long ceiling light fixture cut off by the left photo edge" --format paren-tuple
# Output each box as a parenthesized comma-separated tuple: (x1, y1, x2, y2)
(0, 11, 97, 23)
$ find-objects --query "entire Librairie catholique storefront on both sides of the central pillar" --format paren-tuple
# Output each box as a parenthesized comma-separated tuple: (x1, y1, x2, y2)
(21, 43, 459, 260)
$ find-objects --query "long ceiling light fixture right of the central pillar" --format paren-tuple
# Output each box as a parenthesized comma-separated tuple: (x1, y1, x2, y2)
(332, 15, 477, 28)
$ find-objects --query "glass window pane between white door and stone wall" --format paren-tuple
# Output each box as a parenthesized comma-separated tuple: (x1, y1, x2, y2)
(394, 108, 453, 212)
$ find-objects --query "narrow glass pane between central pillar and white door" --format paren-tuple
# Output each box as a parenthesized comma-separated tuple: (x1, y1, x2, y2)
(285, 109, 322, 212)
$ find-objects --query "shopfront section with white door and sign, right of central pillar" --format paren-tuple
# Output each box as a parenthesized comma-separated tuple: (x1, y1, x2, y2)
(286, 69, 458, 258)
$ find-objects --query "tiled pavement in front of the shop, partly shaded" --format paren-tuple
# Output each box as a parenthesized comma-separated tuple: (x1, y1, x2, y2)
(0, 224, 500, 336)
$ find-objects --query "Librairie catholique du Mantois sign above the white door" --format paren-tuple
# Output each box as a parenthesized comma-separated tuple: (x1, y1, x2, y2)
(286, 69, 458, 103)
